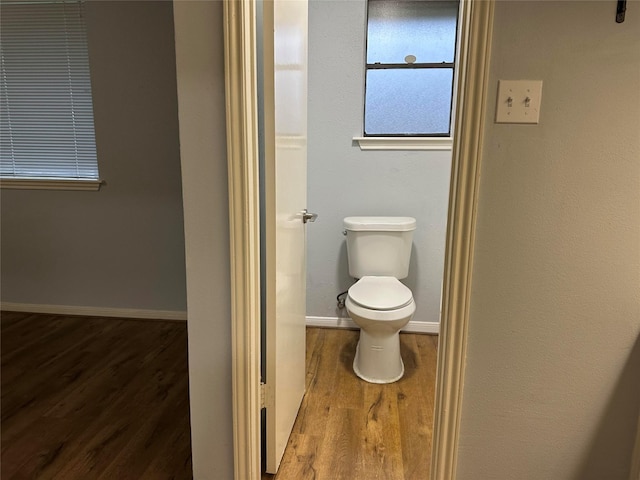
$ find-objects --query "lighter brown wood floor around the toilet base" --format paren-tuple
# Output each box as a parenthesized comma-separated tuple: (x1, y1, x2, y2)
(263, 328, 438, 480)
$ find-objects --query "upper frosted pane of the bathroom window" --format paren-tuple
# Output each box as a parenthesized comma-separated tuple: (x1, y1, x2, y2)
(367, 0, 458, 63)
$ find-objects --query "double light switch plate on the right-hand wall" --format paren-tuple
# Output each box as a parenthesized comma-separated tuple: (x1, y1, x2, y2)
(496, 80, 542, 123)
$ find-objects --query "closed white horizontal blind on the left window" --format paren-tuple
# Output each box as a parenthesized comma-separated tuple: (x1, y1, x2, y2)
(0, 0, 98, 180)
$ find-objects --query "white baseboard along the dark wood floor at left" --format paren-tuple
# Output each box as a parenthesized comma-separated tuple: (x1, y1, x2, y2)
(0, 302, 187, 321)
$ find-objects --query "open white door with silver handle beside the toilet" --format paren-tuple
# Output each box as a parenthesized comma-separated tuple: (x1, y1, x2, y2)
(263, 0, 307, 473)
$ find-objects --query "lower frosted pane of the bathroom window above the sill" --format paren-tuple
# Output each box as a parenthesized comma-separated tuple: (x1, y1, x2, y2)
(364, 68, 453, 135)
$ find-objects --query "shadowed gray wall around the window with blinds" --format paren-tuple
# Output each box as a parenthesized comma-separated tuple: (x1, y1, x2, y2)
(1, 1, 186, 311)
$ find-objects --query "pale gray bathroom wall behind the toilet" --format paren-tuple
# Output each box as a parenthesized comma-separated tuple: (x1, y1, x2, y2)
(307, 0, 451, 322)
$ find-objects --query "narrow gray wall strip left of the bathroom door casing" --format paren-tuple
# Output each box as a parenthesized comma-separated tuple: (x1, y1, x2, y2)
(174, 0, 233, 480)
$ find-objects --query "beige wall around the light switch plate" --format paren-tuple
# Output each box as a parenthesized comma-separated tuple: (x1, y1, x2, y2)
(457, 1, 640, 480)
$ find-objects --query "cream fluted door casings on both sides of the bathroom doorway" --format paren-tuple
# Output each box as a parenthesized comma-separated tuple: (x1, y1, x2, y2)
(223, 0, 495, 480)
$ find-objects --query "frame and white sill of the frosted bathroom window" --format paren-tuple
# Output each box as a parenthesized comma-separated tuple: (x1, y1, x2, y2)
(353, 0, 462, 150)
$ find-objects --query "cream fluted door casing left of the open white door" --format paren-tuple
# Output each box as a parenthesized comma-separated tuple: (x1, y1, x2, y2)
(223, 0, 261, 480)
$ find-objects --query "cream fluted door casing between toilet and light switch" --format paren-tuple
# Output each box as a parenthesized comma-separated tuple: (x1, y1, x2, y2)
(430, 0, 494, 480)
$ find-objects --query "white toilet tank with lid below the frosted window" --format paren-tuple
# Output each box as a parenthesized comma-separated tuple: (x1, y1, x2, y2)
(344, 217, 416, 279)
